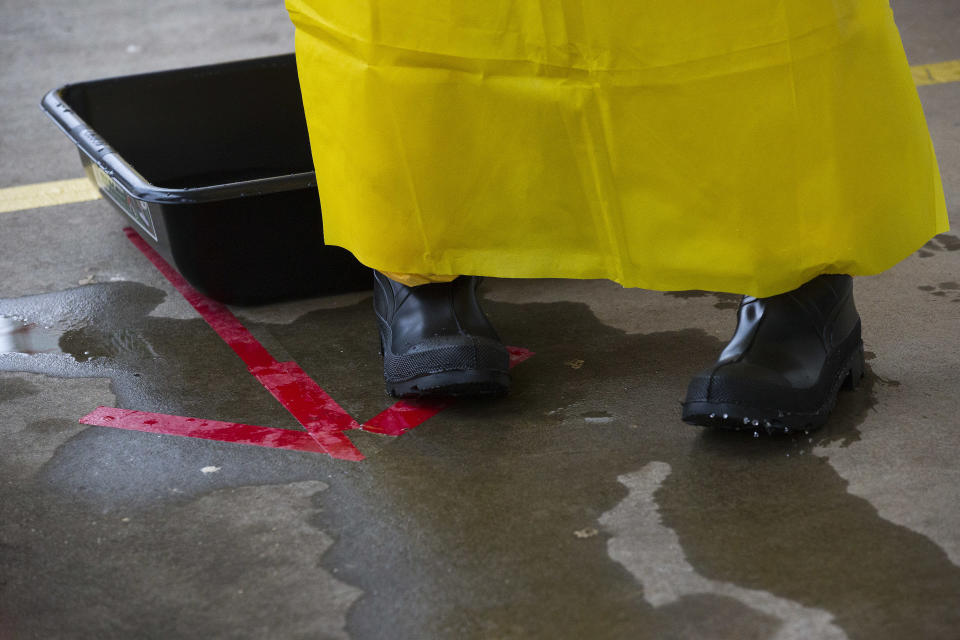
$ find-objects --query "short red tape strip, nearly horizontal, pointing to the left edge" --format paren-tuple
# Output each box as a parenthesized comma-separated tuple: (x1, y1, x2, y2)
(80, 407, 328, 453)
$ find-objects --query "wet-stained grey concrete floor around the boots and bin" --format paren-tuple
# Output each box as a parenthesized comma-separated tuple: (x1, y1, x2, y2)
(0, 0, 960, 640)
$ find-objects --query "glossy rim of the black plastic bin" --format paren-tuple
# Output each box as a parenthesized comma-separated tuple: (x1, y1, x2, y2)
(40, 53, 317, 204)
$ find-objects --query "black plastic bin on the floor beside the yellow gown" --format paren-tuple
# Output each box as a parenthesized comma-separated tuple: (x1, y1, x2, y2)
(42, 54, 371, 304)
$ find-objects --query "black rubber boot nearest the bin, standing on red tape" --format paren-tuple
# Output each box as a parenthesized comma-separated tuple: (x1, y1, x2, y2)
(373, 272, 510, 398)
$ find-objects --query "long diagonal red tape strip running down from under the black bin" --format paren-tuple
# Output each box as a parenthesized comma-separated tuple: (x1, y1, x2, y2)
(123, 227, 363, 460)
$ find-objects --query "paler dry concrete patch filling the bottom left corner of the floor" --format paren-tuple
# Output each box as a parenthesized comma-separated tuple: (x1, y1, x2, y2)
(0, 481, 360, 639)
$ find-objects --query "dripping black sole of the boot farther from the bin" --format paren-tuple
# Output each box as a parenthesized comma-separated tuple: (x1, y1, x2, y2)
(682, 340, 864, 434)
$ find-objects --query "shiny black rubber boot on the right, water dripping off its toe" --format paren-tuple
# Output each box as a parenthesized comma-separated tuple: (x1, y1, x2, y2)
(683, 275, 863, 432)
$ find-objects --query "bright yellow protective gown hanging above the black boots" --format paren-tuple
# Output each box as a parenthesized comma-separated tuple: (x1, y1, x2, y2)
(287, 0, 947, 296)
